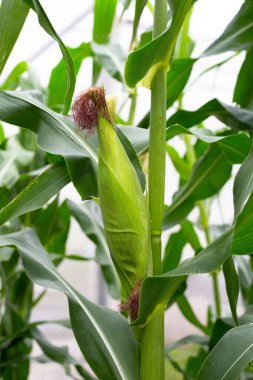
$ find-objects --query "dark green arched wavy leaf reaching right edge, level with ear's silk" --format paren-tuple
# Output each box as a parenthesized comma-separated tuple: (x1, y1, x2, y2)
(167, 99, 253, 131)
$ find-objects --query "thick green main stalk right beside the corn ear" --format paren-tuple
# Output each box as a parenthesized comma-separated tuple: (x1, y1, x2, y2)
(141, 0, 167, 380)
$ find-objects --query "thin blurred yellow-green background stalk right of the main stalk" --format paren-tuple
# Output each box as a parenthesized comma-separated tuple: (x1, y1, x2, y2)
(184, 135, 221, 317)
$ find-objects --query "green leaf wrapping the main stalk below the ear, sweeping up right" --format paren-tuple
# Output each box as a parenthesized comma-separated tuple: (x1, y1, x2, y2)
(133, 229, 233, 326)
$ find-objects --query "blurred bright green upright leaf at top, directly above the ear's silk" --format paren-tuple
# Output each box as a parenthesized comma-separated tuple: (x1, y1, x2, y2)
(92, 0, 117, 83)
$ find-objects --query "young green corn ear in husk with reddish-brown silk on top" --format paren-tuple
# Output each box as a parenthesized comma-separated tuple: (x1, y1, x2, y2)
(72, 88, 150, 297)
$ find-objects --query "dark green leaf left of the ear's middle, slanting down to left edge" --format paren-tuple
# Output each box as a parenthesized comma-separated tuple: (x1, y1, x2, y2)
(0, 160, 70, 225)
